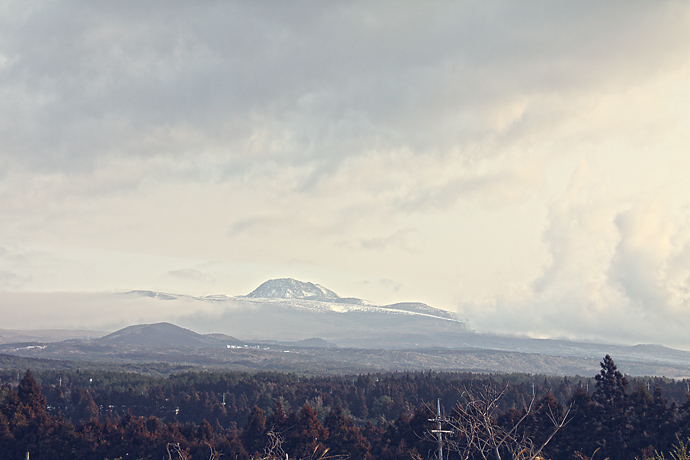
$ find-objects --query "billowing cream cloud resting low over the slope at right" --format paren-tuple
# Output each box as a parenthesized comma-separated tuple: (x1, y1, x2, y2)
(460, 180, 690, 349)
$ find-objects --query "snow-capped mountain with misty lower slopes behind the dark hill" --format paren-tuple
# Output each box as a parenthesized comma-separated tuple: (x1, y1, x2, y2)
(118, 278, 467, 348)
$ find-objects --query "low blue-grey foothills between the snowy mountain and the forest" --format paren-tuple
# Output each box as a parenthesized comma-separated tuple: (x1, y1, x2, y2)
(0, 323, 690, 378)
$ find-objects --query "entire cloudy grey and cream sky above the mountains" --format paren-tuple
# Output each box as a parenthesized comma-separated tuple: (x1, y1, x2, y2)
(0, 0, 690, 349)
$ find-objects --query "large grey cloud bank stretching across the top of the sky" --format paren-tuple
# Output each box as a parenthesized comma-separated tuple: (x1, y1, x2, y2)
(0, 2, 687, 180)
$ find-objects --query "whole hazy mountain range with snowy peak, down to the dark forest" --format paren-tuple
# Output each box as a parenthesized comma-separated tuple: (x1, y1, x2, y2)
(0, 278, 690, 378)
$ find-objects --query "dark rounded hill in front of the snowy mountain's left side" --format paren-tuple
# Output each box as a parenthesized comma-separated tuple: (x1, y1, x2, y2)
(98, 323, 237, 347)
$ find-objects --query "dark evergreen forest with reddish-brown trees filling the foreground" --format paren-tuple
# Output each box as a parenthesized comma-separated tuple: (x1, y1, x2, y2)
(0, 355, 690, 460)
